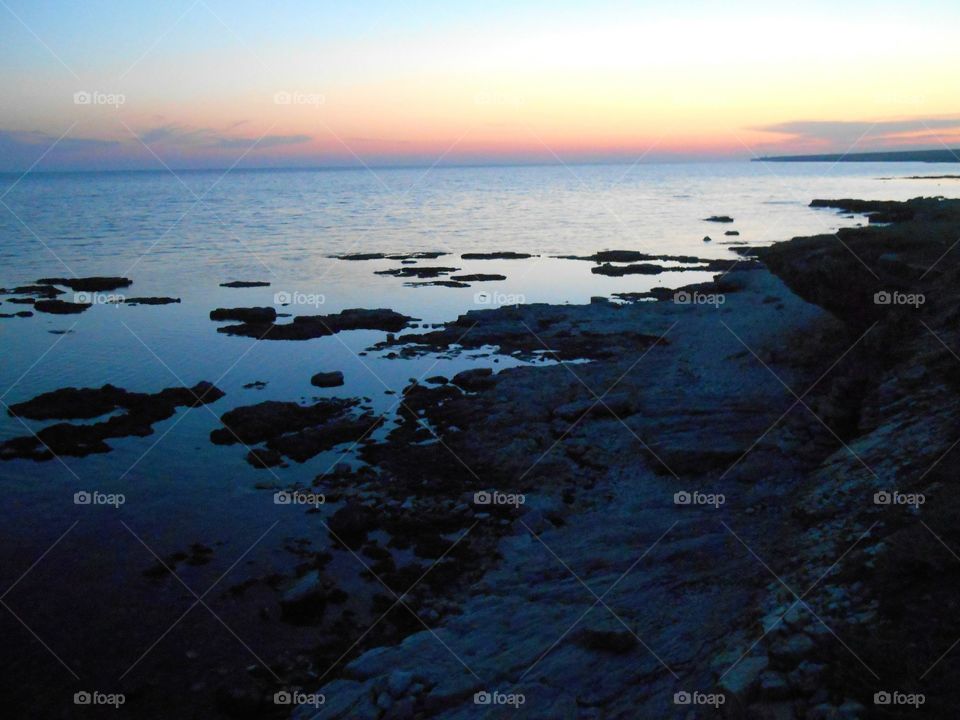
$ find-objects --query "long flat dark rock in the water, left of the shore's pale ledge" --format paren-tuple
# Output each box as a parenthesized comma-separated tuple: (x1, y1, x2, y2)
(217, 308, 414, 340)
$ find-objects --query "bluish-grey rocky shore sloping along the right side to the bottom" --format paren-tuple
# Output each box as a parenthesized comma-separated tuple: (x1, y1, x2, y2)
(286, 194, 960, 718)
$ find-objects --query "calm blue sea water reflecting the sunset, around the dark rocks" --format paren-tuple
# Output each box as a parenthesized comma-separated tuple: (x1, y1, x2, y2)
(0, 163, 960, 716)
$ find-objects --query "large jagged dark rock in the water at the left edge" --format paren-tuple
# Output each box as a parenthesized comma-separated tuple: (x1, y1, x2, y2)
(0, 382, 224, 461)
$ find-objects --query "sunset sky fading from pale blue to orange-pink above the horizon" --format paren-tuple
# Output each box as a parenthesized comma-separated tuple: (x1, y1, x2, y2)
(0, 0, 960, 171)
